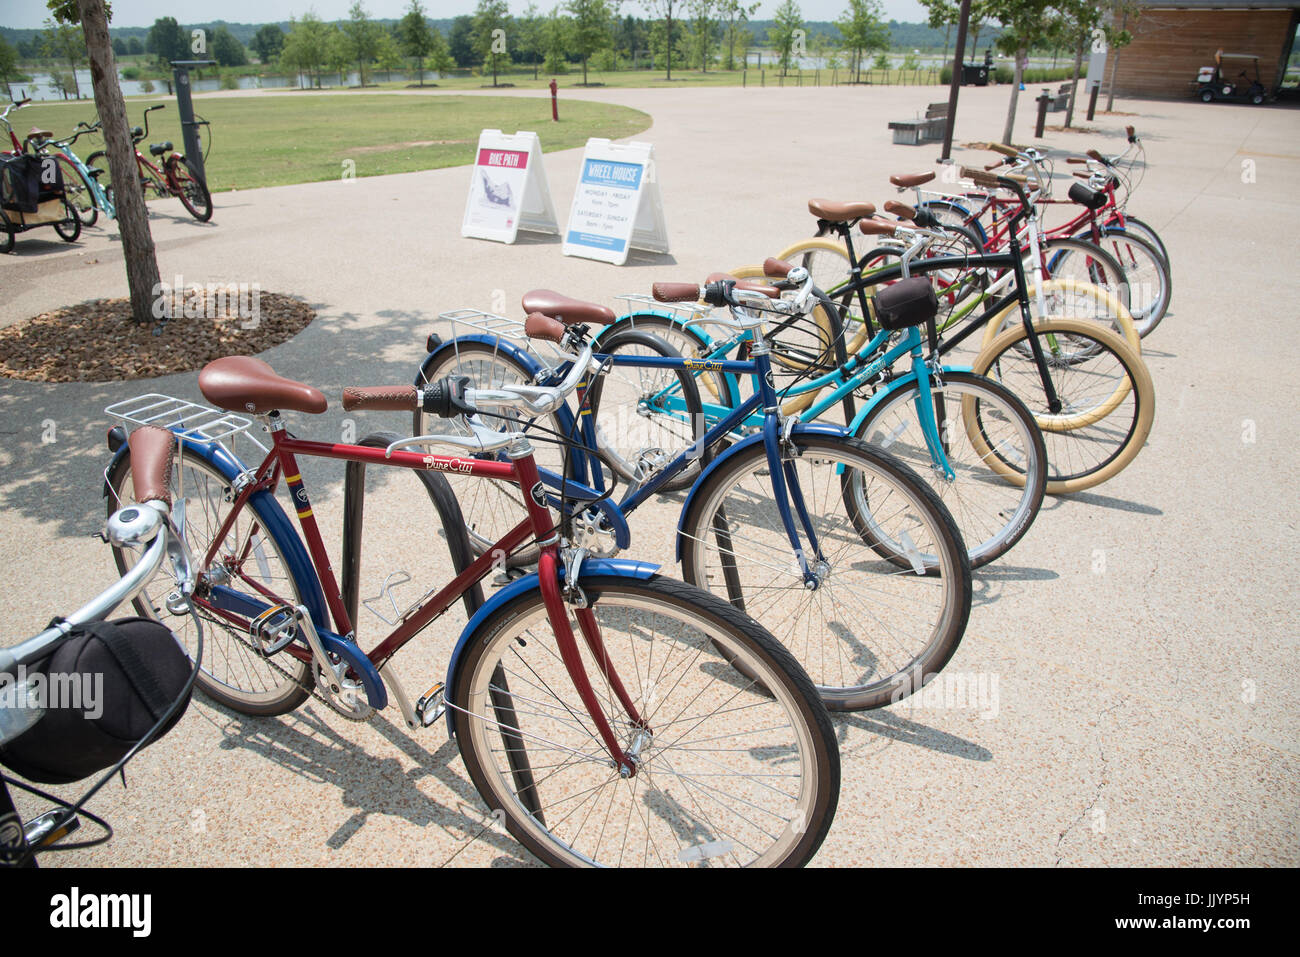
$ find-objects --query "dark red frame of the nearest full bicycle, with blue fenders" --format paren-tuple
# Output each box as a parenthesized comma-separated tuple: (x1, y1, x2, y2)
(116, 415, 655, 776)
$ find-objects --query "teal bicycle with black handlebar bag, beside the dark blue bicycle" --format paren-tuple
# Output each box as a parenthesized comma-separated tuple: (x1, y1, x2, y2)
(598, 254, 1048, 568)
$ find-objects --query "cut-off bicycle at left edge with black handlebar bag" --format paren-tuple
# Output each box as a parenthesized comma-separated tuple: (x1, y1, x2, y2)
(0, 429, 203, 867)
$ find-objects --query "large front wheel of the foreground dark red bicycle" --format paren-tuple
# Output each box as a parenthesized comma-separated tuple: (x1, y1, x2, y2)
(451, 575, 840, 867)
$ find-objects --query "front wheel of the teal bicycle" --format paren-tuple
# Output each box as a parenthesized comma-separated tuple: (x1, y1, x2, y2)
(854, 371, 1048, 568)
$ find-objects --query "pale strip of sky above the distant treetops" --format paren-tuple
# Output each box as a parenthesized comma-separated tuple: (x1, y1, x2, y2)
(0, 0, 924, 29)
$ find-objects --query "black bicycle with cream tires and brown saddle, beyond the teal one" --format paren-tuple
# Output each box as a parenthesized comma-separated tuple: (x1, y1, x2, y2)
(738, 168, 1154, 494)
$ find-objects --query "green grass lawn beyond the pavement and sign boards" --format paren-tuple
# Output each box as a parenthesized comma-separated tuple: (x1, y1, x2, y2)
(10, 92, 651, 192)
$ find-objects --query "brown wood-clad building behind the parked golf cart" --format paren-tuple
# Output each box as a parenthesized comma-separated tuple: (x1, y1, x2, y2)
(1108, 0, 1300, 96)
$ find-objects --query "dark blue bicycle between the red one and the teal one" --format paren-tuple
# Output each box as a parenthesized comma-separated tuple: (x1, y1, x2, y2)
(413, 273, 971, 710)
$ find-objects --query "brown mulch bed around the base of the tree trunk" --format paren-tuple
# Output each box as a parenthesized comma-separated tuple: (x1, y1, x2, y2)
(0, 286, 316, 382)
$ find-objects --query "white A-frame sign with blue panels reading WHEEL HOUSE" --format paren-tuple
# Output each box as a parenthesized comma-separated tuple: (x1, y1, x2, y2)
(564, 139, 668, 265)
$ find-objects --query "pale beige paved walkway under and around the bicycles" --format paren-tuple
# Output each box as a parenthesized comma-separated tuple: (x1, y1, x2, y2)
(0, 87, 1300, 866)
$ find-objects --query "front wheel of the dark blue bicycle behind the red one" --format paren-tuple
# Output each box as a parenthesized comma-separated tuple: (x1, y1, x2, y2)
(681, 433, 971, 711)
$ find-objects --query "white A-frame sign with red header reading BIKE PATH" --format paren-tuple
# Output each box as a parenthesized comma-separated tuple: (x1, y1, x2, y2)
(460, 130, 560, 243)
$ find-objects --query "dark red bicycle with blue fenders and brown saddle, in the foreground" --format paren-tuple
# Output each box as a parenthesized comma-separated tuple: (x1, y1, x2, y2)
(105, 350, 839, 866)
